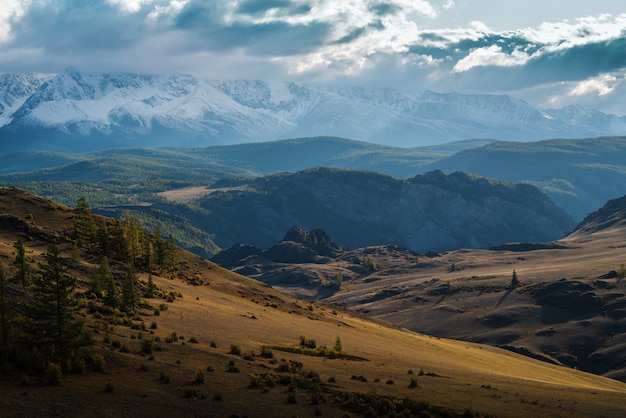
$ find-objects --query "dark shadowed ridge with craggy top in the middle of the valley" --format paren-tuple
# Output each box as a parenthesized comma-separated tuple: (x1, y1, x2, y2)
(188, 168, 574, 252)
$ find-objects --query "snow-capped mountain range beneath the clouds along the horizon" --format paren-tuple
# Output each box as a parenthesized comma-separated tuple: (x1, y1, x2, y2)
(0, 69, 626, 151)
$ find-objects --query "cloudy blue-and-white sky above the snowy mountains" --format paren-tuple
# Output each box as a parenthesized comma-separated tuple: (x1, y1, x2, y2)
(0, 0, 626, 115)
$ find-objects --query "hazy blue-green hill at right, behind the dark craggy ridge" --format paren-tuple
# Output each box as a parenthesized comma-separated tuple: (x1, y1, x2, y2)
(423, 137, 626, 221)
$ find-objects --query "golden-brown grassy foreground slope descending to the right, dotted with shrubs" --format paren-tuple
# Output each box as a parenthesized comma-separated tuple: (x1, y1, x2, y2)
(0, 189, 626, 417)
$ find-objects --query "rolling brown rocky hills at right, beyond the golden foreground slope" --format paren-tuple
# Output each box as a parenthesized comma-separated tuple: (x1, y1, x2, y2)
(210, 193, 626, 381)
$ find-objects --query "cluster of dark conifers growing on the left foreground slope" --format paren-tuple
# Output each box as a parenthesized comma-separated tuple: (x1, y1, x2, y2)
(0, 197, 177, 383)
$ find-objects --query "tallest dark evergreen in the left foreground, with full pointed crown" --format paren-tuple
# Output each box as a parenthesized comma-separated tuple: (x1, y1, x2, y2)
(24, 244, 82, 359)
